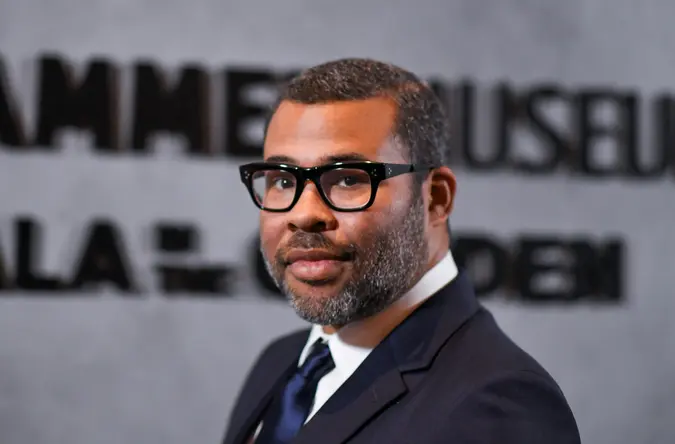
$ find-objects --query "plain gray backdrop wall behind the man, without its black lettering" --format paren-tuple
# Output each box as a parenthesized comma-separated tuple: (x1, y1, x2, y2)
(0, 0, 675, 444)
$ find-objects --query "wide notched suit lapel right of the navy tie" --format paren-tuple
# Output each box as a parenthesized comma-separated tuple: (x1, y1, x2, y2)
(293, 273, 480, 444)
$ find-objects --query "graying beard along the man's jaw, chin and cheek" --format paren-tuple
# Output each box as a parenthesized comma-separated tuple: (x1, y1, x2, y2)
(261, 197, 428, 326)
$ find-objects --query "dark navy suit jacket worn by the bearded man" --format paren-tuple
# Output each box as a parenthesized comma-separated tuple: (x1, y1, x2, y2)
(223, 273, 580, 444)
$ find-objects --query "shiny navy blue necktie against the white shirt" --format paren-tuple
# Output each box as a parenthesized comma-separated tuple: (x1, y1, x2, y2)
(255, 340, 335, 444)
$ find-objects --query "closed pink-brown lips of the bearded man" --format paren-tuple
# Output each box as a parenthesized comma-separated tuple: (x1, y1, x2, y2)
(286, 250, 349, 282)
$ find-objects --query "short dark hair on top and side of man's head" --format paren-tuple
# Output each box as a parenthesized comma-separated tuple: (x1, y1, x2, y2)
(266, 58, 450, 178)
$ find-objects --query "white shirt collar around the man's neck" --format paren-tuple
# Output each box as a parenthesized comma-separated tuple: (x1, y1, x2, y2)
(299, 252, 458, 375)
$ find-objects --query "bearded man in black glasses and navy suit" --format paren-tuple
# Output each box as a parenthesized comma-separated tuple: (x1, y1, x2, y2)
(224, 59, 580, 444)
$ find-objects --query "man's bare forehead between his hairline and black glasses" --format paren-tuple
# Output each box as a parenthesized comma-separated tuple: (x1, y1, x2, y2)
(264, 98, 400, 164)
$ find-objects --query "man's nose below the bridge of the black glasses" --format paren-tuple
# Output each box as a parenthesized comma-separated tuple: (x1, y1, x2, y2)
(288, 182, 337, 232)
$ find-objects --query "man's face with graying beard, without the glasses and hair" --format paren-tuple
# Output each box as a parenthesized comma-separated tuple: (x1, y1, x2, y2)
(260, 98, 427, 326)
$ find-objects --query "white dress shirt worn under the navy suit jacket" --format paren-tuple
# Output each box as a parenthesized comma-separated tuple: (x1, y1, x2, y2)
(254, 252, 458, 437)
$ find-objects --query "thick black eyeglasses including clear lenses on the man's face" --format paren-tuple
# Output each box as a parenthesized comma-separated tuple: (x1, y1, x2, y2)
(239, 162, 434, 212)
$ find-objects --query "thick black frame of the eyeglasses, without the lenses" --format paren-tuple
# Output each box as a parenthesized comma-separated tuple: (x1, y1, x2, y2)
(239, 161, 435, 213)
